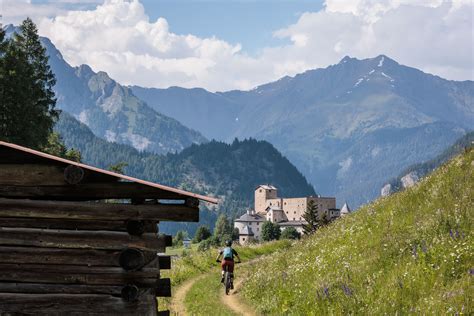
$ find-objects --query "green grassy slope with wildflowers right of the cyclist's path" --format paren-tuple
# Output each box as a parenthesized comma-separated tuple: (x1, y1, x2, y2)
(242, 150, 474, 315)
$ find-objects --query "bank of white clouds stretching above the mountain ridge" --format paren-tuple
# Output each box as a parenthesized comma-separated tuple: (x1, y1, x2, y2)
(18, 0, 474, 90)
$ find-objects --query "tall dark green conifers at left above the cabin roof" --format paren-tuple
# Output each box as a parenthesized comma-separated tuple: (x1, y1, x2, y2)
(0, 18, 59, 149)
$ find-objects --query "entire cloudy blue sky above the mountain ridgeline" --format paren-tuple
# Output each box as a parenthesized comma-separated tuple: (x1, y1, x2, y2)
(0, 0, 474, 91)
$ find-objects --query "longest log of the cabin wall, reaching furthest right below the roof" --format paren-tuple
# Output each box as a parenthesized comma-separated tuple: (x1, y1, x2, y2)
(0, 198, 199, 222)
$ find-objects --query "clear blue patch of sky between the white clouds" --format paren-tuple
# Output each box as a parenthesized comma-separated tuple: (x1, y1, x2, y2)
(141, 0, 323, 54)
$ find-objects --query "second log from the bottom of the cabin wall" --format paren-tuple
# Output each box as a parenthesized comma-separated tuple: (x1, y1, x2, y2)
(0, 263, 160, 288)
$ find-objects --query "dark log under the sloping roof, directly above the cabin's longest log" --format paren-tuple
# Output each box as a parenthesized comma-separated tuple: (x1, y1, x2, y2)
(0, 182, 191, 201)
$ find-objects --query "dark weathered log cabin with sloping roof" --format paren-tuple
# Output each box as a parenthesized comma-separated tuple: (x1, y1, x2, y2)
(0, 141, 217, 315)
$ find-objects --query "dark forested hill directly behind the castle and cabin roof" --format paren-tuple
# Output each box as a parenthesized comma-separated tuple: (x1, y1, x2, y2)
(56, 113, 315, 232)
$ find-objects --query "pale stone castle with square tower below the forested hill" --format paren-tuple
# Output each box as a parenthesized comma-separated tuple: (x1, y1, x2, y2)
(234, 185, 349, 244)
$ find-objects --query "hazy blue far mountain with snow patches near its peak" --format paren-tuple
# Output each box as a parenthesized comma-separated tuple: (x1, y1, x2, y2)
(132, 55, 474, 206)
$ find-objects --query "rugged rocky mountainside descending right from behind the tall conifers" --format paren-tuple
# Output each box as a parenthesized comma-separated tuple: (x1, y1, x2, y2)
(5, 25, 207, 153)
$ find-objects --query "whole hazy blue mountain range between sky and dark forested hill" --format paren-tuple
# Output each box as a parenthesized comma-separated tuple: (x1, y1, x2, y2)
(3, 23, 474, 208)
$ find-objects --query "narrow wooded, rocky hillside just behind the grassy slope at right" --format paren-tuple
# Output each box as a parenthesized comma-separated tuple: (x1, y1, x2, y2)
(382, 132, 474, 196)
